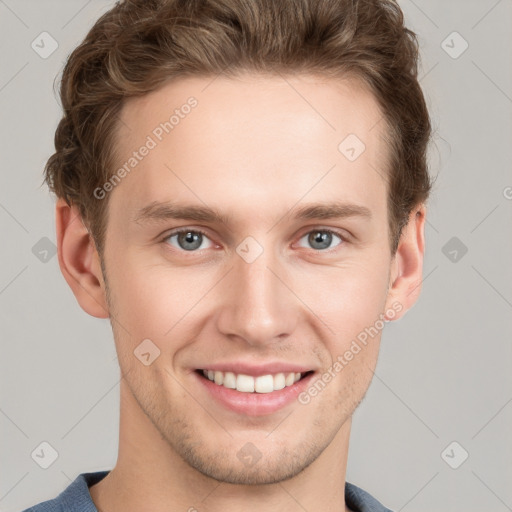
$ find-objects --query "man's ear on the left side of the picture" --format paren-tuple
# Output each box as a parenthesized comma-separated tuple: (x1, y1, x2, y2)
(55, 198, 109, 318)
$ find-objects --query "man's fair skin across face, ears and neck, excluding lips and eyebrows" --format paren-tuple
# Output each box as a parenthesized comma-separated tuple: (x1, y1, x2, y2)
(56, 74, 426, 512)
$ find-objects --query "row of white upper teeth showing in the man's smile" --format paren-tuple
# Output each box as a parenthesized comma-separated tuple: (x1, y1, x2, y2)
(203, 370, 301, 393)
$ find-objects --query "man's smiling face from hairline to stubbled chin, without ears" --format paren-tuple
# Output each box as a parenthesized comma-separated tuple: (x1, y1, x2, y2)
(99, 75, 394, 484)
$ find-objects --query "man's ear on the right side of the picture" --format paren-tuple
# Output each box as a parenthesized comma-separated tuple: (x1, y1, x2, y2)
(386, 204, 427, 320)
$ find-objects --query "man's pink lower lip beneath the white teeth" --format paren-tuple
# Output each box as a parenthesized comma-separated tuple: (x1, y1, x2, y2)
(192, 372, 314, 416)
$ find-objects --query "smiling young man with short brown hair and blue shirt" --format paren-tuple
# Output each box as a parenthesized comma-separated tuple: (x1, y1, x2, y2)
(24, 0, 431, 512)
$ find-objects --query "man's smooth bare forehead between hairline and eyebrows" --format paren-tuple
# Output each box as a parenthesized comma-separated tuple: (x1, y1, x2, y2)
(109, 74, 387, 222)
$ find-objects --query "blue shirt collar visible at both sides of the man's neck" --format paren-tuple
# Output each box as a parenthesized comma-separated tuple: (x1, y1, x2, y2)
(23, 471, 392, 512)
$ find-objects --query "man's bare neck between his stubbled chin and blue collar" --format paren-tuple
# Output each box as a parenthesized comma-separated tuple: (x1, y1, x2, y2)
(90, 380, 350, 512)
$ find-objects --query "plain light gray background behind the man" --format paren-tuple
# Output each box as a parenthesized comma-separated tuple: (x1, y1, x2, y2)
(0, 0, 512, 512)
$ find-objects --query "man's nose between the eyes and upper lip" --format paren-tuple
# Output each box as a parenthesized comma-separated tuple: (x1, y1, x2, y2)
(217, 241, 300, 346)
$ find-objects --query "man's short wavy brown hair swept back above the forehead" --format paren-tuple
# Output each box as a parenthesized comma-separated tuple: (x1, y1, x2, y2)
(45, 0, 432, 255)
